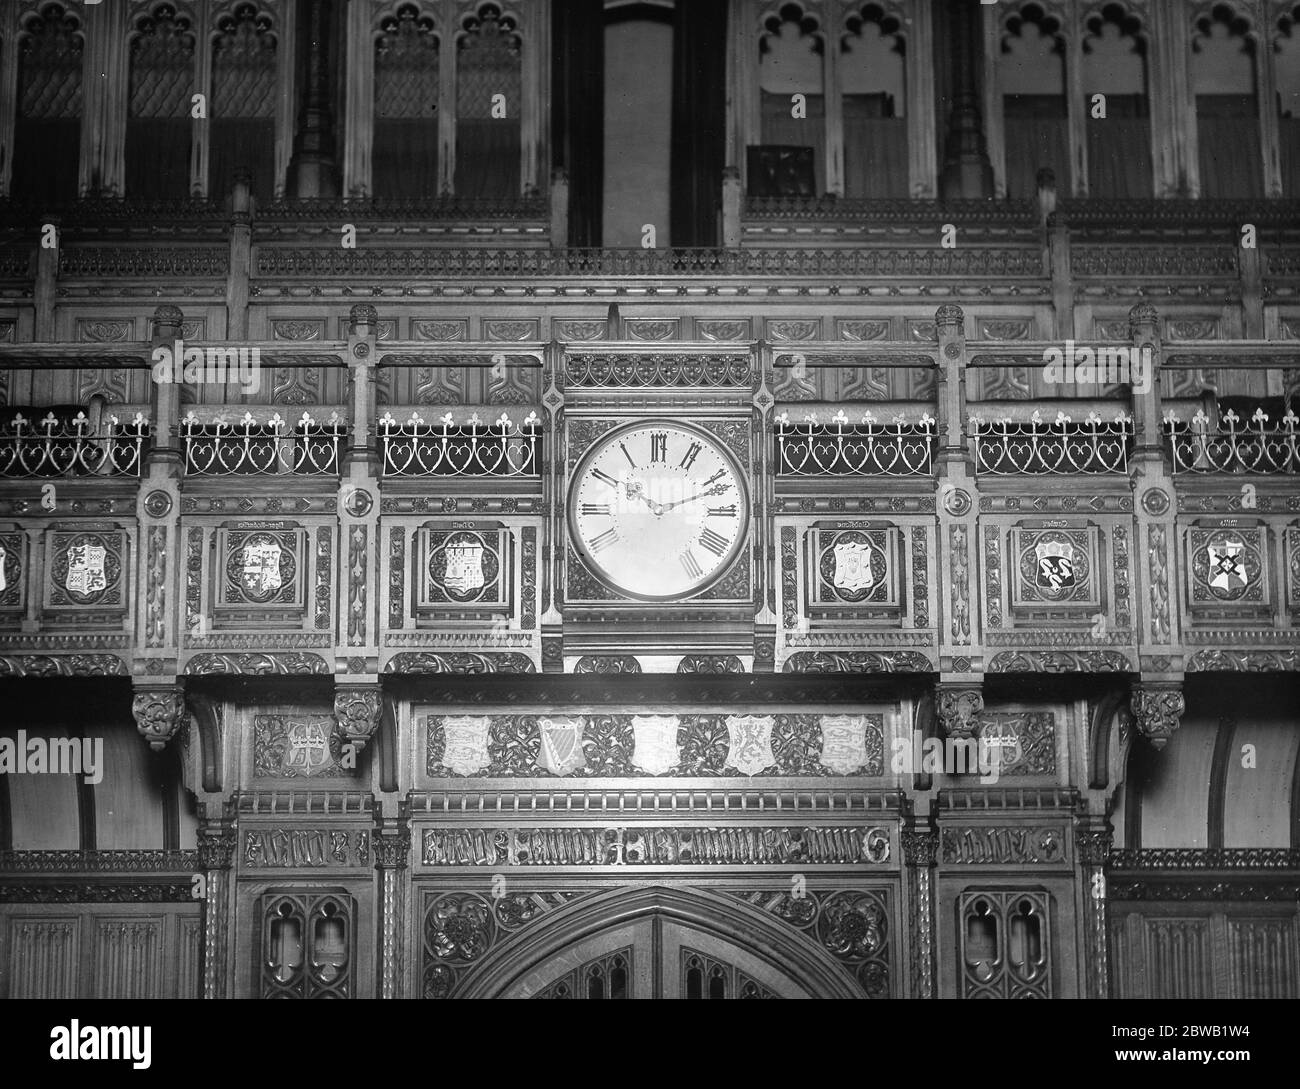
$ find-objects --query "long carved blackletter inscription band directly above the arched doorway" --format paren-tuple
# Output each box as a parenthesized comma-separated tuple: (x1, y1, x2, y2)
(421, 824, 893, 868)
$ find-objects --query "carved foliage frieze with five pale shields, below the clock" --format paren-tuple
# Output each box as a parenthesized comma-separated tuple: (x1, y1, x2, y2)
(425, 715, 885, 778)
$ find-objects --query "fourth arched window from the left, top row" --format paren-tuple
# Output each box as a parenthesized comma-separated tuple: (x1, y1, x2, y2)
(371, 4, 438, 199)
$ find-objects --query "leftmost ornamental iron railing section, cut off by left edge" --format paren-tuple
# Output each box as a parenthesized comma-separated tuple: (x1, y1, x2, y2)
(0, 412, 151, 477)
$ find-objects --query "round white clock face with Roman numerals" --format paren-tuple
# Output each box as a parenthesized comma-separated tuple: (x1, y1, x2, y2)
(568, 420, 749, 602)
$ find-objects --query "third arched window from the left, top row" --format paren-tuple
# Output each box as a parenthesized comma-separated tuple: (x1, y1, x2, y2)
(208, 4, 278, 201)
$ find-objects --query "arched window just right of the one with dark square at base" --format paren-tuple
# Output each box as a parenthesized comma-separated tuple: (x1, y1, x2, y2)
(839, 4, 907, 198)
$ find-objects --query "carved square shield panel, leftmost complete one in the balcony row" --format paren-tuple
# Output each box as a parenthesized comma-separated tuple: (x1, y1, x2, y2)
(43, 522, 130, 625)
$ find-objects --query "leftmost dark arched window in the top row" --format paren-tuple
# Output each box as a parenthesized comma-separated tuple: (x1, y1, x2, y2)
(9, 4, 83, 203)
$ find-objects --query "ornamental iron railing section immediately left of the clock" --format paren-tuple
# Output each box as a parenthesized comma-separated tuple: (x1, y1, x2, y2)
(378, 412, 542, 480)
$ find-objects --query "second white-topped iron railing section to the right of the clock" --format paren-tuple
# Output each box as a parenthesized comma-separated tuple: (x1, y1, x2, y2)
(971, 412, 1134, 477)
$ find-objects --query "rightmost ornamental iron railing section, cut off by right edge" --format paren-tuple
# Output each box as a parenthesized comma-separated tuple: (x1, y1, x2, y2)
(1165, 408, 1300, 473)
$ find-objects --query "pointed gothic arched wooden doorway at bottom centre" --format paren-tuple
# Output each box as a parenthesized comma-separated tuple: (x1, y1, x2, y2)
(441, 886, 866, 998)
